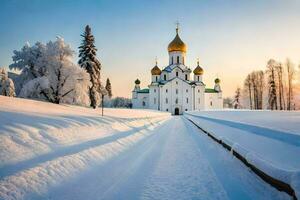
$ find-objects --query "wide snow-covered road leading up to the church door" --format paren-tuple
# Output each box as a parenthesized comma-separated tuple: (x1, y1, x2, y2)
(39, 116, 290, 200)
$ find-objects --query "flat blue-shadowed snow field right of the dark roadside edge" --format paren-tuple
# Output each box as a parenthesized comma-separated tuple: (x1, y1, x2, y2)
(185, 111, 300, 198)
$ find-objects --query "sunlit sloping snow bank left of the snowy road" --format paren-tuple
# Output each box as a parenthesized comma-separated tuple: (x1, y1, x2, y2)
(0, 96, 170, 199)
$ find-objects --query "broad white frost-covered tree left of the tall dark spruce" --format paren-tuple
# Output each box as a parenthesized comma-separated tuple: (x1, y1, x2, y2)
(10, 37, 90, 105)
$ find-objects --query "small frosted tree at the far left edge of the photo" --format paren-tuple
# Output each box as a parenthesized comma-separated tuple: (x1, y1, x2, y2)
(0, 68, 16, 97)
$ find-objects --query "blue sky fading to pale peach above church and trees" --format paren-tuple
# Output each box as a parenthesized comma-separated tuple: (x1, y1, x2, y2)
(0, 0, 300, 97)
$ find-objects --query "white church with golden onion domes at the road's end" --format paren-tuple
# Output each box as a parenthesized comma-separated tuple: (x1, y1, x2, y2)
(132, 27, 223, 115)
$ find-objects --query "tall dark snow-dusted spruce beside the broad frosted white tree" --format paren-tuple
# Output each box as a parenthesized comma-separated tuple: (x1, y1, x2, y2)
(78, 25, 102, 108)
